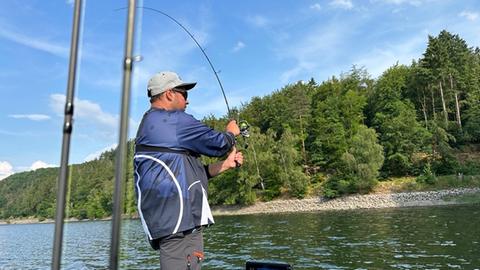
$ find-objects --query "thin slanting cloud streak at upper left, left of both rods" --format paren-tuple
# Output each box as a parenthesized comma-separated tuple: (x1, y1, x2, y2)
(0, 26, 70, 58)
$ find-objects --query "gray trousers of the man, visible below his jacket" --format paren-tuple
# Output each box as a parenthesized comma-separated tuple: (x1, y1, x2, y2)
(160, 227, 204, 270)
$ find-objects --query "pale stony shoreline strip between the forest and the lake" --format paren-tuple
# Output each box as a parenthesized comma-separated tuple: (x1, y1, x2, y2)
(0, 188, 480, 225)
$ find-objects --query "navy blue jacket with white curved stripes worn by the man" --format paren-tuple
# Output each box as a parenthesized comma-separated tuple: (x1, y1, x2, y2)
(134, 108, 235, 240)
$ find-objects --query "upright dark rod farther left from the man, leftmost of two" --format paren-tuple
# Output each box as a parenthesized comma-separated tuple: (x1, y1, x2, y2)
(52, 0, 82, 270)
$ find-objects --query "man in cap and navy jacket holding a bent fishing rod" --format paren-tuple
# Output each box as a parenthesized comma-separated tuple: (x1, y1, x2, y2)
(134, 71, 243, 270)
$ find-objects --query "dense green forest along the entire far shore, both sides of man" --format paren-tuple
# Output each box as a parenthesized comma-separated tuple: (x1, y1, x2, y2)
(0, 31, 480, 219)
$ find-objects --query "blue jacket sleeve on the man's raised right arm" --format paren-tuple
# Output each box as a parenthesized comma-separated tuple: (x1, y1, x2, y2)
(177, 112, 235, 157)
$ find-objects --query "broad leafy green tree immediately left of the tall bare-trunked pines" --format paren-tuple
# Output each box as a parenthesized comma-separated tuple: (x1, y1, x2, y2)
(367, 65, 430, 176)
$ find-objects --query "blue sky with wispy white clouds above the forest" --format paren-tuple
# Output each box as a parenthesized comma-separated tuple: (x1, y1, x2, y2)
(0, 0, 480, 180)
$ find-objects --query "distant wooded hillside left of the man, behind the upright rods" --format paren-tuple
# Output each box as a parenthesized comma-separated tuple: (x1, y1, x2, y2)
(0, 143, 134, 219)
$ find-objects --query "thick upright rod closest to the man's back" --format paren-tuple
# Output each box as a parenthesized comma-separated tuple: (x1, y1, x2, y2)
(110, 0, 136, 269)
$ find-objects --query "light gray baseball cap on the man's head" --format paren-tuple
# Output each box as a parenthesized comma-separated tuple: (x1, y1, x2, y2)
(147, 71, 197, 97)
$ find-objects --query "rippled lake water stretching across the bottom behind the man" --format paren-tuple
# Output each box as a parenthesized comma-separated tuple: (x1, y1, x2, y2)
(0, 205, 480, 270)
